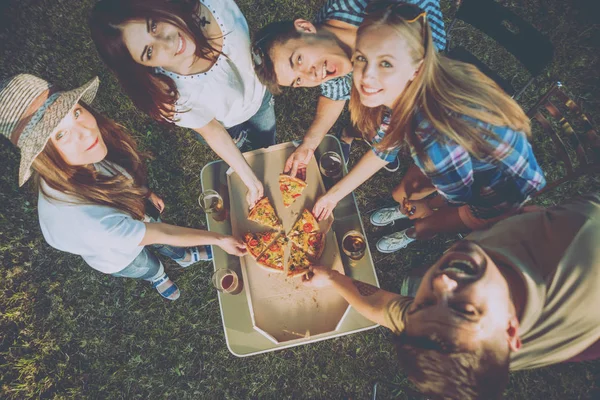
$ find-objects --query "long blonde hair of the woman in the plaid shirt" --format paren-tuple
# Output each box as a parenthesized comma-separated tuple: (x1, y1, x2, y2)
(349, 6, 531, 164)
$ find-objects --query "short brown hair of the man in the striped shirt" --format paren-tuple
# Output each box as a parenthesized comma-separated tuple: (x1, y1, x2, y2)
(252, 21, 302, 94)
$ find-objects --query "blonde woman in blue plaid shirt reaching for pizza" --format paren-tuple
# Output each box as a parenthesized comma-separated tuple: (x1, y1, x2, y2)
(313, 2, 545, 253)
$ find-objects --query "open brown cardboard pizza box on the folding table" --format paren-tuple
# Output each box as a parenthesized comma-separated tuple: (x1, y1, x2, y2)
(227, 143, 349, 344)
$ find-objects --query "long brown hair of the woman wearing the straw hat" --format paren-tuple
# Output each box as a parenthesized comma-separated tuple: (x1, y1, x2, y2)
(32, 103, 148, 220)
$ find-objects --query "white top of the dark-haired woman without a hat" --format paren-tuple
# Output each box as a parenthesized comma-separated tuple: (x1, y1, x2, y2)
(155, 0, 266, 129)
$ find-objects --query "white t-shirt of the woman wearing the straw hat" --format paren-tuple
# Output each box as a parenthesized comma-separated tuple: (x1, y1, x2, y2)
(38, 161, 146, 274)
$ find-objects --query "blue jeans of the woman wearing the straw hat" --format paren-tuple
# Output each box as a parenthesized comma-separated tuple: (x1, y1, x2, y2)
(112, 244, 185, 282)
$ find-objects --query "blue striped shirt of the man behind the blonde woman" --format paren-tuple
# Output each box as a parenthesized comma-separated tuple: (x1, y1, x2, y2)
(315, 0, 446, 100)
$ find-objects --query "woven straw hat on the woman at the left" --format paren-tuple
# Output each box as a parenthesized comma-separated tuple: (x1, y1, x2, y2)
(0, 74, 100, 186)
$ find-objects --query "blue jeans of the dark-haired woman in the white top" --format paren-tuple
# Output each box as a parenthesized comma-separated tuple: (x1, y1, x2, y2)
(227, 90, 275, 150)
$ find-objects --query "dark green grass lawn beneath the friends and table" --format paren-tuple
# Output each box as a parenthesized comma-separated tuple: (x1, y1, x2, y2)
(0, 0, 600, 400)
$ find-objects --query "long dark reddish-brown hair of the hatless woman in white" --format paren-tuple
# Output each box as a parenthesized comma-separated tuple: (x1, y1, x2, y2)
(90, 0, 220, 123)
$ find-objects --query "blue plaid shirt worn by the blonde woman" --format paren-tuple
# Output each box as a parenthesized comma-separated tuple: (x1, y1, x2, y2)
(373, 113, 546, 219)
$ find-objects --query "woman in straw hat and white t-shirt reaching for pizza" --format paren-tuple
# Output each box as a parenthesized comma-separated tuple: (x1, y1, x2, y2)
(0, 74, 246, 300)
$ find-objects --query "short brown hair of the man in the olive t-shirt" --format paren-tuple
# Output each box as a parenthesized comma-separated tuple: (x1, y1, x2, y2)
(394, 333, 510, 400)
